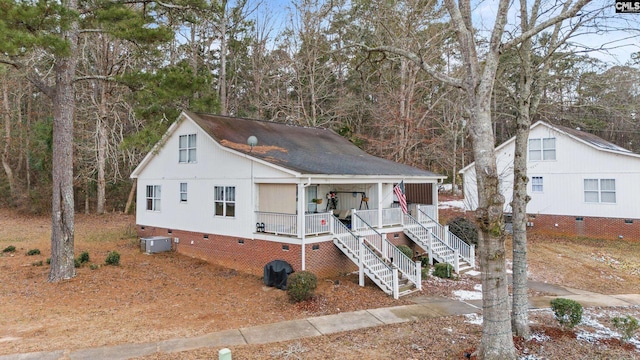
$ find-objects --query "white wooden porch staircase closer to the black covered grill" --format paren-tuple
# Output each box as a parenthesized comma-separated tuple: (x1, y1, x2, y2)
(332, 216, 422, 299)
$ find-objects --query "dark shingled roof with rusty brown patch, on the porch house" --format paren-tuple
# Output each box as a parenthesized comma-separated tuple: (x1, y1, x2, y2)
(185, 112, 441, 178)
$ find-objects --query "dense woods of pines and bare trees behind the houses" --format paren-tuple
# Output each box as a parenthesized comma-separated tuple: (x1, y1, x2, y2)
(0, 0, 640, 213)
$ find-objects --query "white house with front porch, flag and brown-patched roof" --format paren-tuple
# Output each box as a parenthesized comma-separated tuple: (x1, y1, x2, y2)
(131, 112, 473, 293)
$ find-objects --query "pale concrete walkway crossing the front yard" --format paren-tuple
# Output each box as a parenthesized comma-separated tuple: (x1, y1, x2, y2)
(0, 283, 640, 360)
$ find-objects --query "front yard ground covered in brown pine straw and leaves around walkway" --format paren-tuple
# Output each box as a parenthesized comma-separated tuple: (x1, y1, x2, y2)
(0, 210, 640, 359)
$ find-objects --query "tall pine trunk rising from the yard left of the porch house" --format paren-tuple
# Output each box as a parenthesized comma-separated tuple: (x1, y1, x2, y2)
(49, 0, 78, 282)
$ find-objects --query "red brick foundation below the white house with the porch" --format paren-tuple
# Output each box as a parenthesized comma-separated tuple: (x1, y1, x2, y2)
(137, 225, 358, 278)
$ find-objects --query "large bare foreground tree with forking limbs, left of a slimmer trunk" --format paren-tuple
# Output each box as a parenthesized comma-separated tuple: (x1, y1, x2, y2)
(362, 0, 590, 359)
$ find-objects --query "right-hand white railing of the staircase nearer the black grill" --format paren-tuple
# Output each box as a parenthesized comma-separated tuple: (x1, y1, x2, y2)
(351, 212, 422, 290)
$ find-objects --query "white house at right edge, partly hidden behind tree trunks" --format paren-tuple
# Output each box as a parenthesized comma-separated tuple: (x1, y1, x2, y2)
(460, 121, 640, 237)
